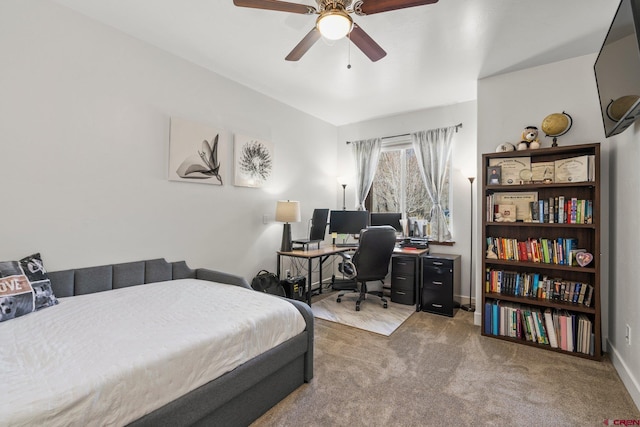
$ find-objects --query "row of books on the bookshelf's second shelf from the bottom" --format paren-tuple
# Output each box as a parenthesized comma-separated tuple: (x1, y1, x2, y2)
(485, 268, 594, 307)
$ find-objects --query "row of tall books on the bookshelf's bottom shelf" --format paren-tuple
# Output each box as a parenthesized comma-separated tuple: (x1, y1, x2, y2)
(483, 300, 595, 356)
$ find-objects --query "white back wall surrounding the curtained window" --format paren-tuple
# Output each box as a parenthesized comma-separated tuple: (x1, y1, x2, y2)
(335, 101, 477, 304)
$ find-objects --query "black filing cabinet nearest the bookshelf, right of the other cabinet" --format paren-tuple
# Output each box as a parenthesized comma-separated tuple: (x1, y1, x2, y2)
(420, 254, 461, 317)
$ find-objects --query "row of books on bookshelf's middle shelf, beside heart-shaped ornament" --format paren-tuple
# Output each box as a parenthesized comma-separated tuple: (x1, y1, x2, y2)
(486, 237, 587, 267)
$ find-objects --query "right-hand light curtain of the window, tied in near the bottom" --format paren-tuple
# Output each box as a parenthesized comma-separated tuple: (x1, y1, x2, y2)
(411, 126, 456, 242)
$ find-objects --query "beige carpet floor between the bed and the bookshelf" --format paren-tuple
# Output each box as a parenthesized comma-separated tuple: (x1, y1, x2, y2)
(252, 298, 640, 427)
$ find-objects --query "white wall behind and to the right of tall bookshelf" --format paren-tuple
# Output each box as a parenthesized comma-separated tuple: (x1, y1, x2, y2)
(476, 54, 640, 406)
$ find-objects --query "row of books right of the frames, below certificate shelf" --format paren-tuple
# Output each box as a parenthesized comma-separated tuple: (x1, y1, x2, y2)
(529, 196, 593, 224)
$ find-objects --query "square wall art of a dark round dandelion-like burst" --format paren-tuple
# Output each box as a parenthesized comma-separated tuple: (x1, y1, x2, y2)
(233, 135, 273, 188)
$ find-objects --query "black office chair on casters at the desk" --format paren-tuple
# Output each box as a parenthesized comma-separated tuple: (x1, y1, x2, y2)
(334, 225, 396, 311)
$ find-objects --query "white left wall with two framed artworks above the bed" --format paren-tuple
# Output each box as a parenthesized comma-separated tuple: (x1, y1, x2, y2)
(0, 0, 337, 279)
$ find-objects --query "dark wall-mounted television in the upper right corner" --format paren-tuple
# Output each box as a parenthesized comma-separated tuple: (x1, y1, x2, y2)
(593, 0, 640, 137)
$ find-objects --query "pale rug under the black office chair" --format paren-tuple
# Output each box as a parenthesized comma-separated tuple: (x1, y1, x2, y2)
(311, 293, 416, 336)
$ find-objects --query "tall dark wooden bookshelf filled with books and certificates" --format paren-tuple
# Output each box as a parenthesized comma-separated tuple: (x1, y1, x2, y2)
(482, 143, 602, 360)
